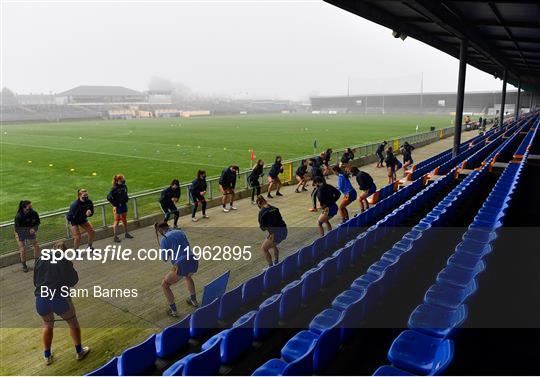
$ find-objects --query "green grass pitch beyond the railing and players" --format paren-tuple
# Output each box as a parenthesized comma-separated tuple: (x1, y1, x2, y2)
(0, 114, 451, 221)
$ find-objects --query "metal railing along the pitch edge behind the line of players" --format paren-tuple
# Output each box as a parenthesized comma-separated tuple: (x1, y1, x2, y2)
(0, 127, 454, 255)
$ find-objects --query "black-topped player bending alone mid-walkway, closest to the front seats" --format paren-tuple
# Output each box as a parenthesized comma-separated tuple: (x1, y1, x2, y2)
(257, 195, 287, 267)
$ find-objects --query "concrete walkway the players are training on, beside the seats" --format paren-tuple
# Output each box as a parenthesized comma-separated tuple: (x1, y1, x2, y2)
(0, 132, 476, 375)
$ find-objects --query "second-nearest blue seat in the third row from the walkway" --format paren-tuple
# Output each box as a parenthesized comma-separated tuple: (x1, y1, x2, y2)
(281, 309, 344, 372)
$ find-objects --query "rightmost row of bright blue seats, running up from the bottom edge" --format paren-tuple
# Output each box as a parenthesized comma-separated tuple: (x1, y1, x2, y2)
(375, 154, 524, 375)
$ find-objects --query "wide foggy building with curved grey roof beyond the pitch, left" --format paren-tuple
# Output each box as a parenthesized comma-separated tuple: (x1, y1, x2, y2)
(56, 85, 146, 105)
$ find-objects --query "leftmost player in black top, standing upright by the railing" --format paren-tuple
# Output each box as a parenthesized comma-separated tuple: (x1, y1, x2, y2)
(13, 200, 41, 272)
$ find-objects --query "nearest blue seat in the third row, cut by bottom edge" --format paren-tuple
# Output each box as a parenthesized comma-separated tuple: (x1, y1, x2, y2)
(252, 341, 317, 376)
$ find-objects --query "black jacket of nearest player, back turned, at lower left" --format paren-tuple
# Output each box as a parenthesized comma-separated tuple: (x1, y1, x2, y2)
(34, 258, 79, 297)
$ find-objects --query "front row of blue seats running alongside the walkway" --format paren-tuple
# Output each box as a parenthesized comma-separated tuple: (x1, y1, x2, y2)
(89, 122, 508, 375)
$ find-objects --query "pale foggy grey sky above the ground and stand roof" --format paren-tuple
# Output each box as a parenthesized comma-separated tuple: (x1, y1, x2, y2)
(2, 0, 513, 99)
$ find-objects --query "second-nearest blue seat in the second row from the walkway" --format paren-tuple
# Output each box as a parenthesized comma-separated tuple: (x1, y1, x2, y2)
(201, 310, 257, 364)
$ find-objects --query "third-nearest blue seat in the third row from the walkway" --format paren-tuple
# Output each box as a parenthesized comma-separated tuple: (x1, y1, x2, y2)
(332, 289, 366, 340)
